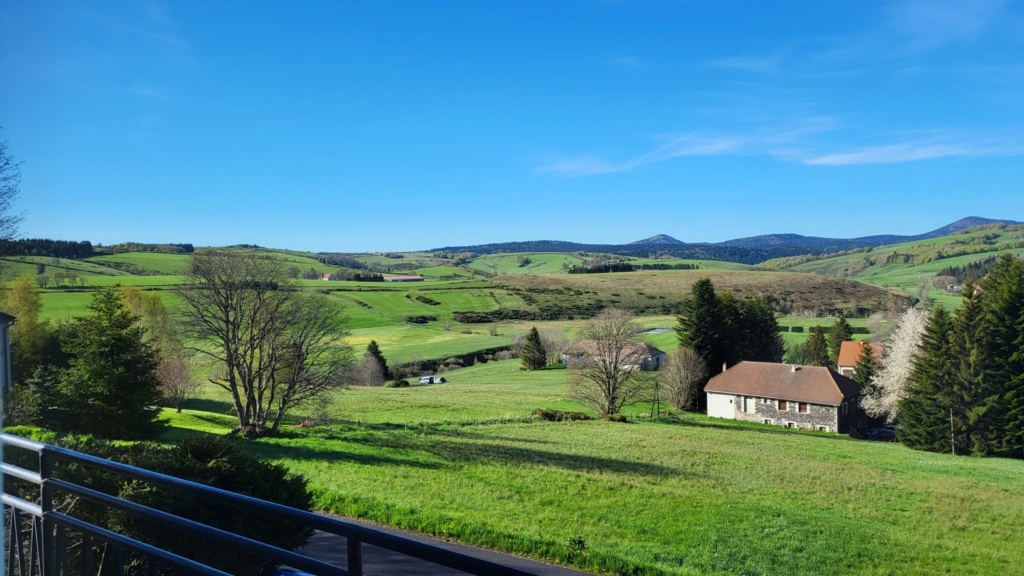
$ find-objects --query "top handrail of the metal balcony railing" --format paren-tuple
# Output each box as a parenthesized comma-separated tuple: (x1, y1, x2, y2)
(0, 434, 531, 576)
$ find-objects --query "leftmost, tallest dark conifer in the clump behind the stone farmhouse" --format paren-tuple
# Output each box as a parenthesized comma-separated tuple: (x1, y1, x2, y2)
(676, 278, 735, 375)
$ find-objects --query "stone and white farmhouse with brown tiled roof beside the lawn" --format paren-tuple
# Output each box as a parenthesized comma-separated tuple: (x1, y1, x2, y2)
(705, 362, 863, 434)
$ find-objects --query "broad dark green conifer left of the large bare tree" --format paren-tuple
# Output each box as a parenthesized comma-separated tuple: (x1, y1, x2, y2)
(47, 287, 166, 440)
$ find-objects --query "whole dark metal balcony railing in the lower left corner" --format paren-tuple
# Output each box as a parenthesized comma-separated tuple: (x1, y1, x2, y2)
(0, 434, 529, 576)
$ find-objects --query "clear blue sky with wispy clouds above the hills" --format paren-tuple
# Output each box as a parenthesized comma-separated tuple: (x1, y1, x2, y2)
(0, 0, 1024, 251)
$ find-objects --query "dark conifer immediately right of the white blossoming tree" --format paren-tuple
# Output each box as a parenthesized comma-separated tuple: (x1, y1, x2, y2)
(899, 305, 963, 452)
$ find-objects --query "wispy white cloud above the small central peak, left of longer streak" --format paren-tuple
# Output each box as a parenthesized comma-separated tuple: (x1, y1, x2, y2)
(534, 133, 744, 177)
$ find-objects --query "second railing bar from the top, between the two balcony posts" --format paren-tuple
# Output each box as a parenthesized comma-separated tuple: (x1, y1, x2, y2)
(46, 478, 348, 576)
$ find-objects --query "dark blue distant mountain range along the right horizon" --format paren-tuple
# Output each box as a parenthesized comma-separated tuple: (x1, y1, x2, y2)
(434, 216, 1021, 264)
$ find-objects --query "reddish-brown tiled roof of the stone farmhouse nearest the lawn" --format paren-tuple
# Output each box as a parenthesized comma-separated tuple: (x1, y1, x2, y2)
(705, 362, 861, 406)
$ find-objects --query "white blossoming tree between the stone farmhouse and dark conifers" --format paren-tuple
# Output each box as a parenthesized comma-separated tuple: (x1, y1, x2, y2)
(861, 308, 928, 420)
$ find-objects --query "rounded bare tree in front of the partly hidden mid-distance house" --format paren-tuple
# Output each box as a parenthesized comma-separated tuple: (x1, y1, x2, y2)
(568, 310, 654, 416)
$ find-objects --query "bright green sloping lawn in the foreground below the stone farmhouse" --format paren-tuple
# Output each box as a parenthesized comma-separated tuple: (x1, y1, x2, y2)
(165, 361, 1024, 575)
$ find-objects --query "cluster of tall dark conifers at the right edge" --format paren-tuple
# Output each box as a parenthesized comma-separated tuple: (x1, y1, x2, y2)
(896, 254, 1024, 458)
